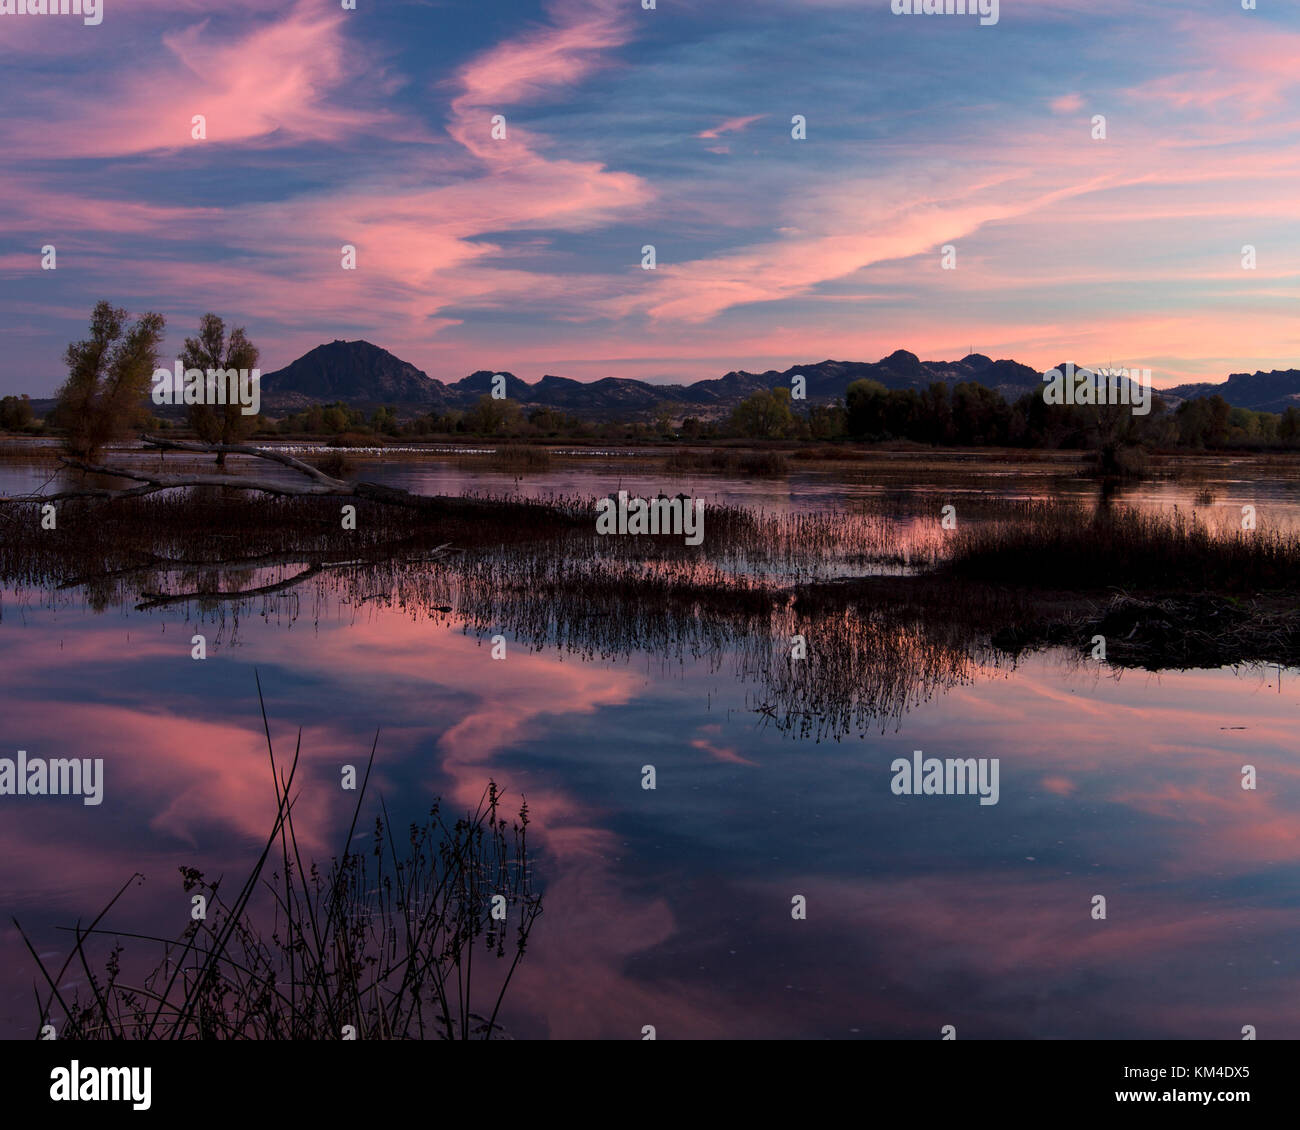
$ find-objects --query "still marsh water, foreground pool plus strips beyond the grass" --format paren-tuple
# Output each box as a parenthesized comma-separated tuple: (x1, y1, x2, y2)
(0, 444, 1300, 1039)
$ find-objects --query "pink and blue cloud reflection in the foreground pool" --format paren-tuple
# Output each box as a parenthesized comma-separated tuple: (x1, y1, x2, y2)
(0, 455, 1300, 1039)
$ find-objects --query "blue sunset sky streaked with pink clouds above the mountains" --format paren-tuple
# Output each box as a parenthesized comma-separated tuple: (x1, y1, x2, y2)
(0, 0, 1300, 397)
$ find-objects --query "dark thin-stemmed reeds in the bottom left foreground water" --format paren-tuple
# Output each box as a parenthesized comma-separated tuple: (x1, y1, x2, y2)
(16, 685, 542, 1040)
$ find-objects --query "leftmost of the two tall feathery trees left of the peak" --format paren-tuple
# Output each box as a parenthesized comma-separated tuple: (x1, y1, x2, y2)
(55, 302, 164, 460)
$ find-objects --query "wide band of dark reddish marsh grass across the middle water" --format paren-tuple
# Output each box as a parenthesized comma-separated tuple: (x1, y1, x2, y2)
(0, 489, 1300, 739)
